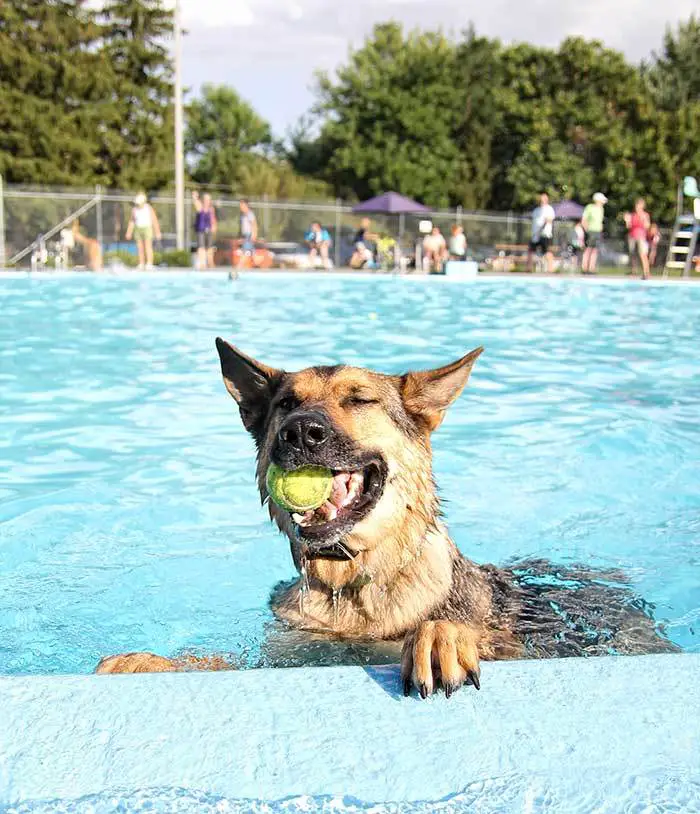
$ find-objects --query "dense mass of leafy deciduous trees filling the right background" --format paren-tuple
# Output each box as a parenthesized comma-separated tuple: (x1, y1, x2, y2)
(291, 17, 700, 218)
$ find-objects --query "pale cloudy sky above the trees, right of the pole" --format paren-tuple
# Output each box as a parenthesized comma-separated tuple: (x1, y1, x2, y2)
(179, 0, 697, 137)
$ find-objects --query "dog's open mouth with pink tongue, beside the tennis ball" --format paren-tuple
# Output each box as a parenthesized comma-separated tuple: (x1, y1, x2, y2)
(292, 461, 386, 556)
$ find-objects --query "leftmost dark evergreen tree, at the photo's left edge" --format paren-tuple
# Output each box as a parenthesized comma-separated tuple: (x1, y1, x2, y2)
(0, 0, 109, 186)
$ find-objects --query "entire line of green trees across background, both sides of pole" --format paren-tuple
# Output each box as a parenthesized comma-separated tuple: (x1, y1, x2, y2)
(0, 5, 700, 220)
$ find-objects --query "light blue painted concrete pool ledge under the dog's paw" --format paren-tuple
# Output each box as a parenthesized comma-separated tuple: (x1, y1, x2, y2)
(0, 654, 700, 811)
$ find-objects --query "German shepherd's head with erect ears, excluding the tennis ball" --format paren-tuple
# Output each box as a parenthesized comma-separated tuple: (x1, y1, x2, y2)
(216, 339, 483, 580)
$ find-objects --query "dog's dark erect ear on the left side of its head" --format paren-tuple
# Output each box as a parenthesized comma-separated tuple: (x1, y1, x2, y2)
(216, 337, 282, 432)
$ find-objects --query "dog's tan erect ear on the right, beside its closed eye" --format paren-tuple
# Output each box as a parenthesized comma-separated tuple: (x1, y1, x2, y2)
(401, 348, 484, 432)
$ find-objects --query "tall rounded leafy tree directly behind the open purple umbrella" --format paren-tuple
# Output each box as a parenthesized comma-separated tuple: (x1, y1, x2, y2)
(310, 23, 466, 206)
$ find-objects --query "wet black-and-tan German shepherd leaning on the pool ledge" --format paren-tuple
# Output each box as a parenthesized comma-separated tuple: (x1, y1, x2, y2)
(97, 339, 676, 698)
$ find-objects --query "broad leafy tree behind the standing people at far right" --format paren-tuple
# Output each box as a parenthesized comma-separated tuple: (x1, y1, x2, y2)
(486, 38, 654, 212)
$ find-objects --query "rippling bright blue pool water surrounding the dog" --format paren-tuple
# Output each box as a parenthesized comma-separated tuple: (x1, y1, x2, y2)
(0, 275, 700, 673)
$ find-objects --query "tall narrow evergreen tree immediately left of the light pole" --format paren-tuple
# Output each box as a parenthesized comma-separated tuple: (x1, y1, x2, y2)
(98, 0, 174, 189)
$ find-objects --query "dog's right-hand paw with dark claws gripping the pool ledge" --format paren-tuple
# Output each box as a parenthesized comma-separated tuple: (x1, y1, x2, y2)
(401, 621, 479, 698)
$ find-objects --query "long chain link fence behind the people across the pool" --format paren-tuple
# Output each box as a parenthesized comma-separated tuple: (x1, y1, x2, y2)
(0, 179, 668, 268)
